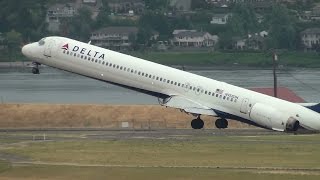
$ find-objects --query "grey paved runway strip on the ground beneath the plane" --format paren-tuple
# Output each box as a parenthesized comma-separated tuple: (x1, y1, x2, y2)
(0, 128, 312, 144)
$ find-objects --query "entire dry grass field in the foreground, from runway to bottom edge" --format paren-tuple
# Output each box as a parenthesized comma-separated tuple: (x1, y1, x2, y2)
(0, 135, 320, 180)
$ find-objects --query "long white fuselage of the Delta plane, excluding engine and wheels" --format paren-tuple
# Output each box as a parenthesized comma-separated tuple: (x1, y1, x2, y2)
(22, 37, 320, 131)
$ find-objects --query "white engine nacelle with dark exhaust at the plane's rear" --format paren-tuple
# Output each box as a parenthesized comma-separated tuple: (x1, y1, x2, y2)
(250, 103, 299, 131)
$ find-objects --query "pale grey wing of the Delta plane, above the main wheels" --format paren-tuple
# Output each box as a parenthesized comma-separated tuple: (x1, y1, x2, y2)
(162, 96, 218, 116)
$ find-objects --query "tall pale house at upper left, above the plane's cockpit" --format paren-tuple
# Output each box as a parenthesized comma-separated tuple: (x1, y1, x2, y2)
(46, 3, 78, 32)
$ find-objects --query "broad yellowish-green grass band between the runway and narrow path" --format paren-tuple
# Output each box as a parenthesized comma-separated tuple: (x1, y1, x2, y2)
(1, 135, 320, 168)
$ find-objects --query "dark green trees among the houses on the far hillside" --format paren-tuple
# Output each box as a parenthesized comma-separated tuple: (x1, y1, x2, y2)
(0, 0, 319, 52)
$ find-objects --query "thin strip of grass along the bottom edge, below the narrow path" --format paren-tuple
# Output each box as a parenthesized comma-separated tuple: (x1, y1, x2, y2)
(0, 165, 319, 180)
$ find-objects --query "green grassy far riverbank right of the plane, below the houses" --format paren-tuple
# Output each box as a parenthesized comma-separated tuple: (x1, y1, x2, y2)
(132, 52, 320, 68)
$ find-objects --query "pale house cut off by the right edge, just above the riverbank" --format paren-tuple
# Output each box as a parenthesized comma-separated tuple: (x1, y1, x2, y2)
(300, 28, 320, 49)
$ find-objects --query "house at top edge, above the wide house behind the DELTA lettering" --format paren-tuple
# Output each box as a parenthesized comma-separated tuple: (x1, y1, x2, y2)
(108, 0, 146, 14)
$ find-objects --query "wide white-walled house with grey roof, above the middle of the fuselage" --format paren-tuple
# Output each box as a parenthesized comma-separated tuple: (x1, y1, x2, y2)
(172, 30, 219, 47)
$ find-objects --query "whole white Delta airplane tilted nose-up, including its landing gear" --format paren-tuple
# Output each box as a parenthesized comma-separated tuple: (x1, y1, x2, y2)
(22, 36, 320, 132)
